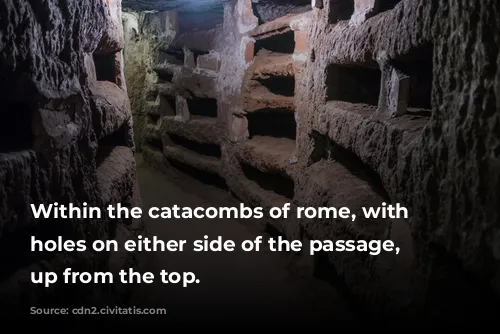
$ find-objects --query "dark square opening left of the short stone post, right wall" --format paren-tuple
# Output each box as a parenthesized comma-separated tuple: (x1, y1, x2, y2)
(326, 64, 382, 106)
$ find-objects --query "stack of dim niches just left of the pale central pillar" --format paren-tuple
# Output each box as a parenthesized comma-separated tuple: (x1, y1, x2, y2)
(144, 88, 226, 188)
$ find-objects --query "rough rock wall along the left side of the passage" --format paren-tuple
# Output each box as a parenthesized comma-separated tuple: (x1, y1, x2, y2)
(0, 0, 142, 316)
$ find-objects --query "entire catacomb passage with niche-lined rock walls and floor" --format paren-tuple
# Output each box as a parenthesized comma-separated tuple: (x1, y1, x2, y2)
(0, 0, 500, 324)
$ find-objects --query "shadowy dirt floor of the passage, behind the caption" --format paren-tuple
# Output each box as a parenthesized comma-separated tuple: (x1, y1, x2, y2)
(129, 155, 352, 322)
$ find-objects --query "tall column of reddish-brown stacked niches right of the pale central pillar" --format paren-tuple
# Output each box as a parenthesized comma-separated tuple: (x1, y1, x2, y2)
(237, 15, 300, 202)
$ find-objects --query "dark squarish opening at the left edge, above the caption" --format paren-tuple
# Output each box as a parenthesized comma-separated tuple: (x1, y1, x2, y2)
(0, 101, 34, 153)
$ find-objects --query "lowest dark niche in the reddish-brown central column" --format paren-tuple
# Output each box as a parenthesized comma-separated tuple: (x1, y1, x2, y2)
(241, 163, 295, 199)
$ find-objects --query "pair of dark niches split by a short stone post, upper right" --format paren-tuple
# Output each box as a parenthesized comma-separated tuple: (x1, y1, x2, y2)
(326, 45, 433, 119)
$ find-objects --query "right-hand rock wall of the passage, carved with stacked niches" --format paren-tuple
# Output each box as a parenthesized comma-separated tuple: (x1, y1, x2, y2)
(127, 0, 500, 319)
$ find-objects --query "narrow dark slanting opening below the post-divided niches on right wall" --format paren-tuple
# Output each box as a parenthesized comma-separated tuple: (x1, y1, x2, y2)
(310, 131, 391, 203)
